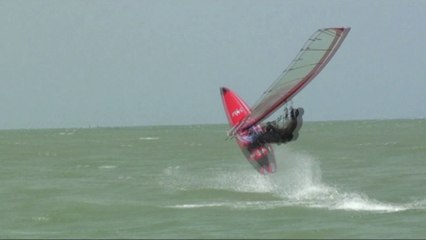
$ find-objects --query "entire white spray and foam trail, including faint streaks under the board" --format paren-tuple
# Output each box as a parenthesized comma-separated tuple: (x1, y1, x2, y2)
(164, 149, 426, 213)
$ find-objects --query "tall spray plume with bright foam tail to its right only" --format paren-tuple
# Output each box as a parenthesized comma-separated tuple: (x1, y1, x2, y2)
(271, 149, 409, 212)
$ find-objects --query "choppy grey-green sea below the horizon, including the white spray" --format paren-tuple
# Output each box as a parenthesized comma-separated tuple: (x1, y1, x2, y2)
(0, 119, 426, 239)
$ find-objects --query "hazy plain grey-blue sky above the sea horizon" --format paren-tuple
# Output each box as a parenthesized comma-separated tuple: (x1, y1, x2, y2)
(0, 0, 426, 129)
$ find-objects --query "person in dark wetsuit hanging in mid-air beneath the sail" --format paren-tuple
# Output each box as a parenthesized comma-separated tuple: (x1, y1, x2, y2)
(248, 108, 304, 149)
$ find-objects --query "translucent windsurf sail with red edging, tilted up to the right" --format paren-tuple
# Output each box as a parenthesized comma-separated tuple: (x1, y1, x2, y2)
(231, 28, 350, 135)
